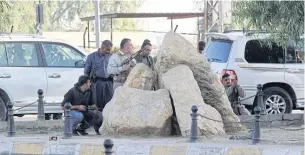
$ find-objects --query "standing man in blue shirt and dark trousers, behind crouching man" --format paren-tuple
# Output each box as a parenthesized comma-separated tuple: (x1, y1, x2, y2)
(84, 40, 113, 111)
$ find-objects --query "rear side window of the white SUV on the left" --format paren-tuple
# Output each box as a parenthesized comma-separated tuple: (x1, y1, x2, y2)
(0, 43, 39, 67)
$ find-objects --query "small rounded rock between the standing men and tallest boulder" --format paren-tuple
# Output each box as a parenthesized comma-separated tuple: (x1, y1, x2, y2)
(124, 63, 156, 90)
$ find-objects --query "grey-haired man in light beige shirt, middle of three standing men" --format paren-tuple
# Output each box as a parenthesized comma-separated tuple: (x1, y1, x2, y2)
(107, 38, 135, 89)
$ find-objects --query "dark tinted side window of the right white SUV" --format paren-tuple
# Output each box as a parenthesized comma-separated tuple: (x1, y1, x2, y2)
(245, 40, 285, 63)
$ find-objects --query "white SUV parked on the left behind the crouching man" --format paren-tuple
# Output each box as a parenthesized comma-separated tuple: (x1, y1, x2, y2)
(0, 34, 87, 121)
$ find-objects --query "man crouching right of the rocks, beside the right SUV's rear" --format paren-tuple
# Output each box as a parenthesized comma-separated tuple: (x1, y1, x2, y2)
(221, 74, 251, 115)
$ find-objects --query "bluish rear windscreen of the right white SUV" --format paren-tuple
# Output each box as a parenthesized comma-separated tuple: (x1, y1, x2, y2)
(204, 40, 233, 63)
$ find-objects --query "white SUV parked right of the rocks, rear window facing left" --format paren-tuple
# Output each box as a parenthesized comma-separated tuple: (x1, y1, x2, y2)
(203, 32, 304, 114)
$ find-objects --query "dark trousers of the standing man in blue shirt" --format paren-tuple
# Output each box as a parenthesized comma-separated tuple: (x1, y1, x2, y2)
(91, 80, 113, 111)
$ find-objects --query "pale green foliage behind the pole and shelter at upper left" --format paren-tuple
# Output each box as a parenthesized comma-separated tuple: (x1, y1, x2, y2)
(0, 0, 141, 33)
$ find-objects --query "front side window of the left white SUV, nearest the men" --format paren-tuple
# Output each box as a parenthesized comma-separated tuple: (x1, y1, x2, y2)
(42, 43, 84, 67)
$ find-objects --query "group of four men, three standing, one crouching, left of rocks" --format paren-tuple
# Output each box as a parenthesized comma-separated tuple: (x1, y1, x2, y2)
(62, 38, 154, 136)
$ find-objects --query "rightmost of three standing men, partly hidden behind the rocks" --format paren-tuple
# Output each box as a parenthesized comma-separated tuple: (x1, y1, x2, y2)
(135, 39, 154, 70)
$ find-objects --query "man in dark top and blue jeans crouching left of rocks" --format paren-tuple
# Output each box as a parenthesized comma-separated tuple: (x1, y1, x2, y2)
(61, 75, 103, 136)
